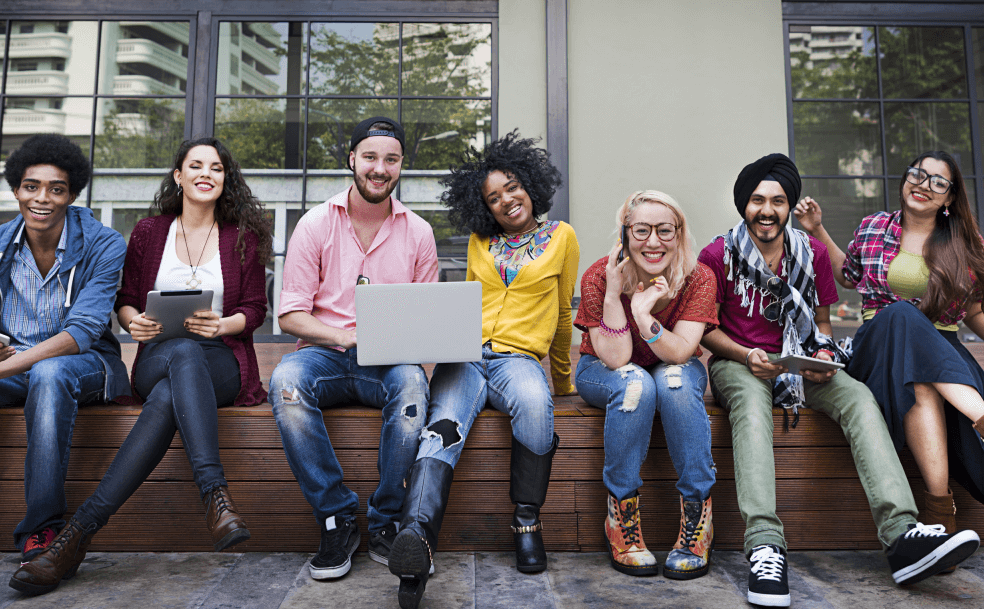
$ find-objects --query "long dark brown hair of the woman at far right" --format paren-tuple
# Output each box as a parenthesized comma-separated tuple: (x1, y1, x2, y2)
(899, 150, 984, 322)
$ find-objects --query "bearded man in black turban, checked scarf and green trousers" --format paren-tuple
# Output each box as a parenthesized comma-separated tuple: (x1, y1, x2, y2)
(699, 154, 977, 607)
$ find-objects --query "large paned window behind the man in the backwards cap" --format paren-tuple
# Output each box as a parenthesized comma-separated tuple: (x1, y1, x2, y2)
(215, 21, 493, 300)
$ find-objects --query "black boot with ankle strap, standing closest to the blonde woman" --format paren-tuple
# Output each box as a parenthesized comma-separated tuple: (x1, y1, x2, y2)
(509, 434, 560, 573)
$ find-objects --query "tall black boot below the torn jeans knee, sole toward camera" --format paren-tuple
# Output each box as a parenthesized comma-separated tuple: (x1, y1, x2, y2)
(389, 458, 454, 609)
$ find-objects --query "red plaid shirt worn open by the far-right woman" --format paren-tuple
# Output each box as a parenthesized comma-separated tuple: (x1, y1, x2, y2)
(842, 211, 984, 326)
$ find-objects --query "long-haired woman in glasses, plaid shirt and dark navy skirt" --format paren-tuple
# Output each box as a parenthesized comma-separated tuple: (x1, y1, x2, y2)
(795, 151, 984, 552)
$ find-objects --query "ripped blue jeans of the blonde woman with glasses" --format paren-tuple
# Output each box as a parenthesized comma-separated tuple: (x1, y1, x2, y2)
(574, 355, 716, 501)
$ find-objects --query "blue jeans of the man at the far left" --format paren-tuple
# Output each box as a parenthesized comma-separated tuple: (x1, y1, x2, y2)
(0, 351, 106, 548)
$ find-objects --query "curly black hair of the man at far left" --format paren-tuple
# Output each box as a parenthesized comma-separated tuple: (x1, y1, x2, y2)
(3, 133, 92, 197)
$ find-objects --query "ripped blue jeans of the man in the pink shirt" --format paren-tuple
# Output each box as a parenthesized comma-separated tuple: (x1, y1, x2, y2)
(268, 347, 428, 533)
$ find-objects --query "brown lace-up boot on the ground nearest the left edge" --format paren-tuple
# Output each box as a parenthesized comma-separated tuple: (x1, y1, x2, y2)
(10, 518, 93, 596)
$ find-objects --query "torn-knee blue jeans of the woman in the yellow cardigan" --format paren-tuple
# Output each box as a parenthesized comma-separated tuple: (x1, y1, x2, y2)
(417, 347, 553, 467)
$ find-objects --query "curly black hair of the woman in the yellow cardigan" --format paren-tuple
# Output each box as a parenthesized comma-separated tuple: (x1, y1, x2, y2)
(441, 130, 563, 237)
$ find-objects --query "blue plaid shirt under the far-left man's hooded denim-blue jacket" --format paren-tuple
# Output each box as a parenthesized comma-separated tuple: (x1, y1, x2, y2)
(0, 222, 68, 352)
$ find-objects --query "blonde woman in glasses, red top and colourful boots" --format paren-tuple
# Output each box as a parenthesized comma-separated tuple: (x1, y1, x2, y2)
(574, 190, 718, 579)
